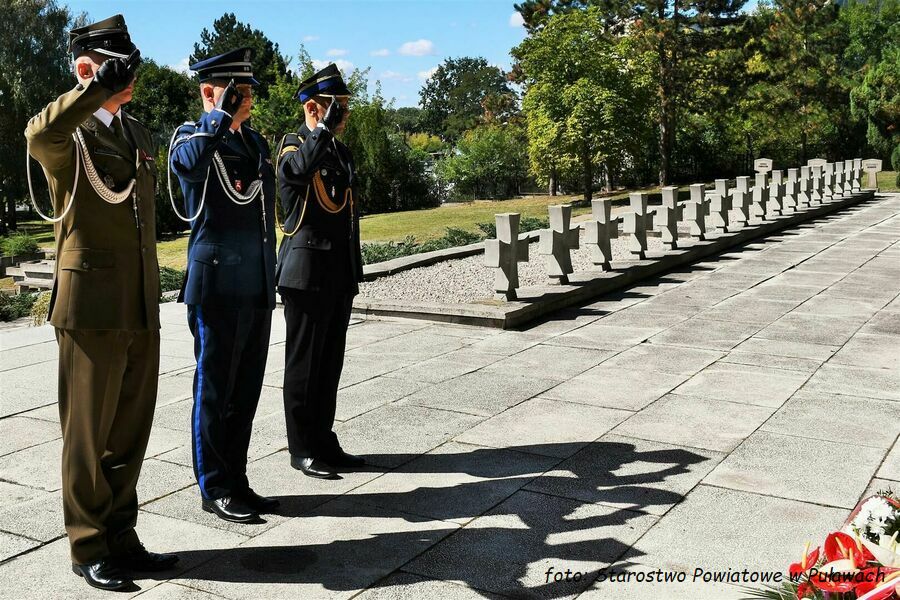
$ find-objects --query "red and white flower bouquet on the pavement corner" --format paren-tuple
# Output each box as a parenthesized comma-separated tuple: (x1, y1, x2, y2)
(747, 491, 900, 600)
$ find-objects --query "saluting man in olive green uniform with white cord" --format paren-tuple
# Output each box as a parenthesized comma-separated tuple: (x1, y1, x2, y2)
(25, 15, 178, 590)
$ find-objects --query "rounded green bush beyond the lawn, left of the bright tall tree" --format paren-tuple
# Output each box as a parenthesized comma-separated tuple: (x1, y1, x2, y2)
(435, 124, 528, 198)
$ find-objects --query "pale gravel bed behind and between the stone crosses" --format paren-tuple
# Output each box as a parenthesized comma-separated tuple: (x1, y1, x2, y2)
(359, 211, 768, 304)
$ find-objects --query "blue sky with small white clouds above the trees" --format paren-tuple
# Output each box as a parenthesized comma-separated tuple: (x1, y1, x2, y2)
(60, 0, 525, 106)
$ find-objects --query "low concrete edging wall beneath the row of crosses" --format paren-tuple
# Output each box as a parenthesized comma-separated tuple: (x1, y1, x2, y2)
(353, 190, 875, 329)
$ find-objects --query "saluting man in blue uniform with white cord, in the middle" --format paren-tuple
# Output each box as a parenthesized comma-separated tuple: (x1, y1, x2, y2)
(169, 48, 278, 523)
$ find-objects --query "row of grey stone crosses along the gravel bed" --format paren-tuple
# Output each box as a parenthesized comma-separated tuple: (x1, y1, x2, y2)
(485, 158, 881, 300)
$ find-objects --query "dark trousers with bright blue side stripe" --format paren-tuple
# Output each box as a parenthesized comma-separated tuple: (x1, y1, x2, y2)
(188, 304, 272, 500)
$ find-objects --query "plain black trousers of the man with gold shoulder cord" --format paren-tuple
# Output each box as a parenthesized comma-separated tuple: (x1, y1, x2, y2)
(279, 288, 354, 457)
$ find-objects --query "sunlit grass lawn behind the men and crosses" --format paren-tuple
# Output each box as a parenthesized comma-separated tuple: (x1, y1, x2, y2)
(5, 171, 900, 269)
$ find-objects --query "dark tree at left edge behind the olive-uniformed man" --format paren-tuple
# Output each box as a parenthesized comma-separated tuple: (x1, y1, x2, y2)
(0, 0, 84, 234)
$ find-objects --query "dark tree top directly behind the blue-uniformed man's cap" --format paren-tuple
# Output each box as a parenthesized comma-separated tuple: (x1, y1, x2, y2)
(189, 13, 288, 98)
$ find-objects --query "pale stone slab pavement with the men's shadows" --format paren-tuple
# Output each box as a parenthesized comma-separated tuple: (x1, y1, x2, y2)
(0, 194, 900, 600)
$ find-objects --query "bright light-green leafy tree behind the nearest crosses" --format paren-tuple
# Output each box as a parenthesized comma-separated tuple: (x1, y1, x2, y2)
(513, 8, 653, 200)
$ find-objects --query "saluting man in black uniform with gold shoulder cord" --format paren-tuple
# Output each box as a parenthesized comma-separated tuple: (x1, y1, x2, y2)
(276, 64, 365, 479)
